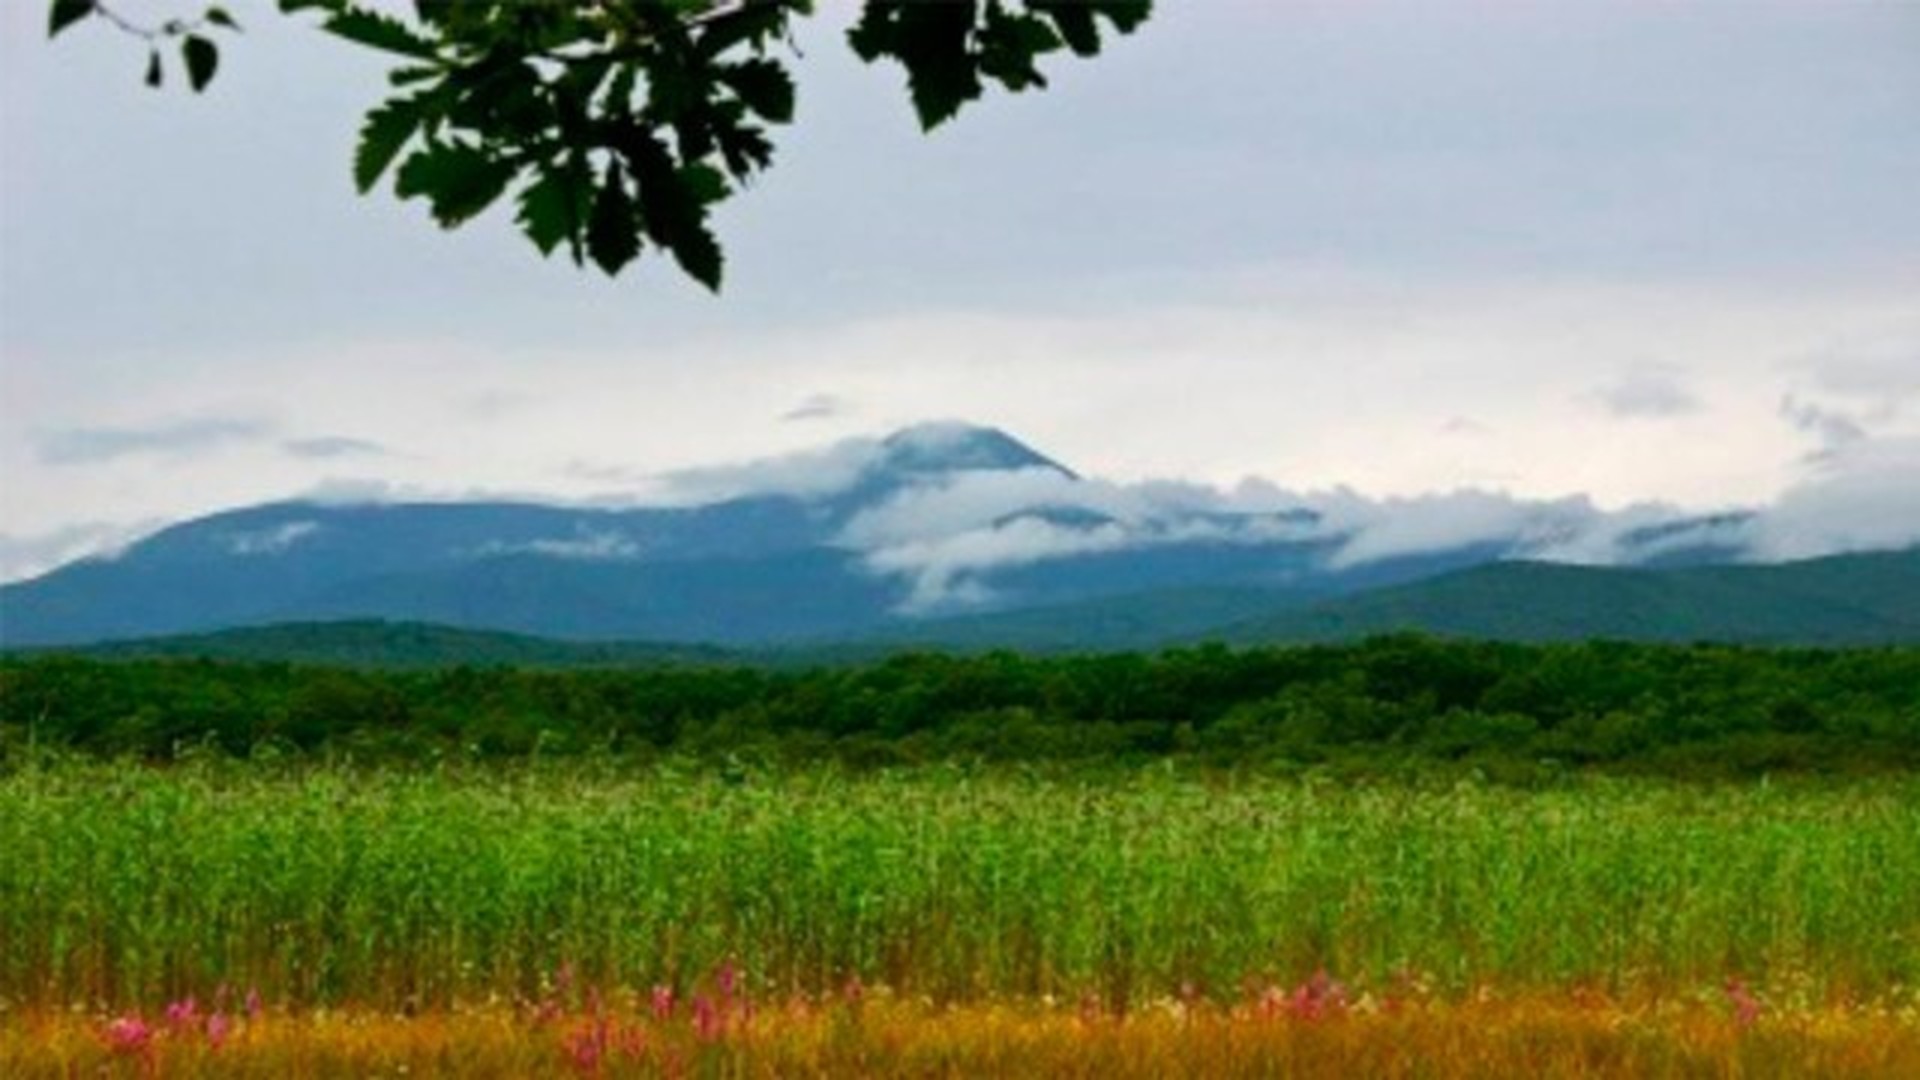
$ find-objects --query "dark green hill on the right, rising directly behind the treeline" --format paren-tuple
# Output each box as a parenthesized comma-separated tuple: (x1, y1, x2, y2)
(1200, 548, 1920, 646)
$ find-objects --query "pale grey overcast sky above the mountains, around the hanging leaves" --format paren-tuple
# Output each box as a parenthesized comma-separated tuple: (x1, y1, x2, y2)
(0, 0, 1920, 580)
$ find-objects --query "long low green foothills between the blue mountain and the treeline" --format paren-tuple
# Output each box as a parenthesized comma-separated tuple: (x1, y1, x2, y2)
(18, 550, 1920, 667)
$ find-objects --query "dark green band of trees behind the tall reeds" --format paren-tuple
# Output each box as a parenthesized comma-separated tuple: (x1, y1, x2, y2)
(0, 636, 1920, 778)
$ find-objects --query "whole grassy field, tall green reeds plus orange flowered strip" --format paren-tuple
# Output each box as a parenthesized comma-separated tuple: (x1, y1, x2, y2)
(0, 763, 1920, 1076)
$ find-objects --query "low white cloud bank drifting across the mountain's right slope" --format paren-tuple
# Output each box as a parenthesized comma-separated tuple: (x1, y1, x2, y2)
(733, 424, 1920, 613)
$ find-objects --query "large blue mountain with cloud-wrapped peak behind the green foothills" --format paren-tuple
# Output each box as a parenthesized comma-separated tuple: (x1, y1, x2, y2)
(0, 423, 1452, 646)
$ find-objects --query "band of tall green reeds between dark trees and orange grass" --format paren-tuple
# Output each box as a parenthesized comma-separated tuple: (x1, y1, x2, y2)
(0, 763, 1920, 1007)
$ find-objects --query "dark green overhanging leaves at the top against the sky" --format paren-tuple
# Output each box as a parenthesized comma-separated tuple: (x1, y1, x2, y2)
(48, 0, 1152, 290)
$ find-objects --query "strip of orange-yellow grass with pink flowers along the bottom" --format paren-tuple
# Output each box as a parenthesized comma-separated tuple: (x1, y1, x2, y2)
(0, 986, 1920, 1080)
